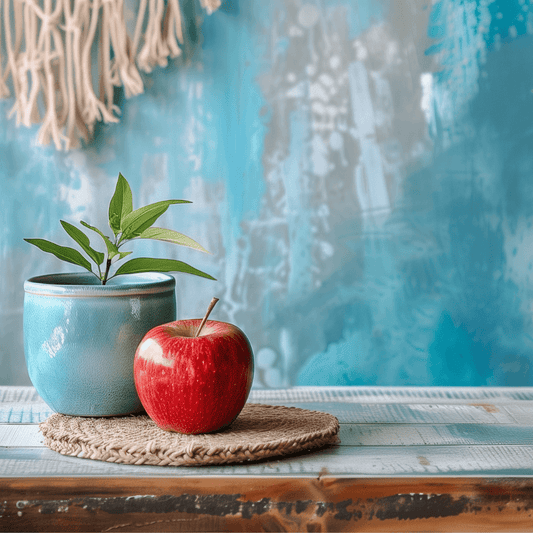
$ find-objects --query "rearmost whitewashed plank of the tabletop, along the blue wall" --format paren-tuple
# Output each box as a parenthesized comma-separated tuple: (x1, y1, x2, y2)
(0, 387, 533, 425)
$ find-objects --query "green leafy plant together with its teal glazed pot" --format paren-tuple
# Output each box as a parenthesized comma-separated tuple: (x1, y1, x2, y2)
(24, 174, 215, 416)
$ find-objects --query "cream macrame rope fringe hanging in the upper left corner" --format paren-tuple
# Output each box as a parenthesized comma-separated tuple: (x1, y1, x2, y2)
(0, 0, 221, 150)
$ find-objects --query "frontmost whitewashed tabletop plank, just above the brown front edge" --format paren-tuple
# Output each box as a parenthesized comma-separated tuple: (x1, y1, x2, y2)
(0, 445, 533, 478)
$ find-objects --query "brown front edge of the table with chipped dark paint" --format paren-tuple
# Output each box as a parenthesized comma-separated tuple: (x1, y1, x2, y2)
(0, 475, 533, 532)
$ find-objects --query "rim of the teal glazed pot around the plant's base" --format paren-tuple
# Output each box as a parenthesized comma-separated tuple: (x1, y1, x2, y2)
(24, 272, 176, 298)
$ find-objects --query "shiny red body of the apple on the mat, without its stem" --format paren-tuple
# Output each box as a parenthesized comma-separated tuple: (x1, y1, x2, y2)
(133, 319, 254, 434)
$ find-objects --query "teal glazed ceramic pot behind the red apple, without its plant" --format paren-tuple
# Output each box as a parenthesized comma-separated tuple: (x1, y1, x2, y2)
(24, 273, 176, 416)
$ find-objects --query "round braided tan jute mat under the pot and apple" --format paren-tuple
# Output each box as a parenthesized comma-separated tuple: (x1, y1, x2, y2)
(39, 404, 339, 466)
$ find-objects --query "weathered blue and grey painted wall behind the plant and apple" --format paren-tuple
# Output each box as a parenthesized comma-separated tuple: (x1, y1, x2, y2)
(0, 0, 533, 387)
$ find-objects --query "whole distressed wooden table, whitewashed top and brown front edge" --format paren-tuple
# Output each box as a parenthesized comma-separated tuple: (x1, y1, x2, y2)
(0, 387, 533, 532)
